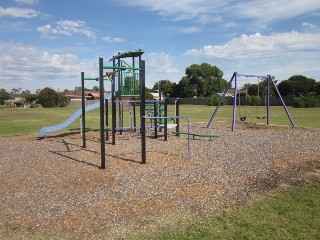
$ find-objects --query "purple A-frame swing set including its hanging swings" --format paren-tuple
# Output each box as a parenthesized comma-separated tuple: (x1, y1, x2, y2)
(207, 72, 295, 132)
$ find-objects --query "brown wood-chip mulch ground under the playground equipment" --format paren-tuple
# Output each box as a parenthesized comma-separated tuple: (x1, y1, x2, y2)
(0, 123, 320, 239)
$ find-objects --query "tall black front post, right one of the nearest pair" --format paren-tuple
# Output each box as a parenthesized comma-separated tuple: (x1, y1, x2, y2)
(139, 60, 147, 164)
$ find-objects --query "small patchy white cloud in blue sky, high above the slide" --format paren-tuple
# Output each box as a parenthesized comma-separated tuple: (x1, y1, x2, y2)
(37, 20, 96, 40)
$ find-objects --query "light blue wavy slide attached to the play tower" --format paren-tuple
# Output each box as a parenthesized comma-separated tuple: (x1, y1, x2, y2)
(39, 93, 111, 138)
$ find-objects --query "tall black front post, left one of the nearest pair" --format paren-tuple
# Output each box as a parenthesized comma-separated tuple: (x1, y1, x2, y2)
(99, 58, 106, 169)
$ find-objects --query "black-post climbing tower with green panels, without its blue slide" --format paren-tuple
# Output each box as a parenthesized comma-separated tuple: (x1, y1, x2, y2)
(81, 50, 184, 169)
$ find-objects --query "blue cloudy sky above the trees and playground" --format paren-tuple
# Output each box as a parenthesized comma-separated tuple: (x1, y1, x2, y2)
(0, 0, 320, 92)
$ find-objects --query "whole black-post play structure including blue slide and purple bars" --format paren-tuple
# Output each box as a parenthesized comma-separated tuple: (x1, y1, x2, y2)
(39, 49, 217, 169)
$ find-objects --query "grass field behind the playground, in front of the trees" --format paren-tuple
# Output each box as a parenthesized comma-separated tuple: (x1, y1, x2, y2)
(0, 105, 320, 136)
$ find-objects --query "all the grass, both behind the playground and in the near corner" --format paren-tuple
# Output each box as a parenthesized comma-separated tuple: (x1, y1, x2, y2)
(0, 105, 320, 239)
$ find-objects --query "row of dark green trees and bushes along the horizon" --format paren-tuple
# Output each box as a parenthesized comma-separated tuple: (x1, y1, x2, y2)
(0, 63, 320, 107)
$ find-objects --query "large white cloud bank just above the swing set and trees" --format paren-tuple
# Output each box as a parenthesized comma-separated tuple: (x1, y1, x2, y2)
(185, 32, 320, 79)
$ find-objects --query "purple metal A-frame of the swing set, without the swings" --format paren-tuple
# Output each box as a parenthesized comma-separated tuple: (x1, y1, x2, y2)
(207, 72, 295, 132)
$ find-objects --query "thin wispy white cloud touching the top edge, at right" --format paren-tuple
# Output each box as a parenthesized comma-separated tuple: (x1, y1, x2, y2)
(114, 0, 320, 25)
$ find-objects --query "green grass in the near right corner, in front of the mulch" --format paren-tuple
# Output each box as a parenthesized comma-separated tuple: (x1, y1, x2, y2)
(137, 172, 320, 240)
